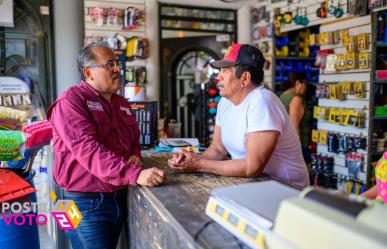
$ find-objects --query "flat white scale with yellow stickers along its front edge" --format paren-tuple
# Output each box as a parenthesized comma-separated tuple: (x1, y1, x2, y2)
(206, 181, 300, 249)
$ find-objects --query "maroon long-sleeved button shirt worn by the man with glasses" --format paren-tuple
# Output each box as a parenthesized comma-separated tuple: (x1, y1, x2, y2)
(47, 81, 141, 192)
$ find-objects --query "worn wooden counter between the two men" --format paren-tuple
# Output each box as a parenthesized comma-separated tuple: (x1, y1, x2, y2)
(128, 153, 270, 249)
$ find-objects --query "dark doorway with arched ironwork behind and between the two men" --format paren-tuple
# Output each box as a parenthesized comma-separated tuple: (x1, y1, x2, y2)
(159, 4, 237, 142)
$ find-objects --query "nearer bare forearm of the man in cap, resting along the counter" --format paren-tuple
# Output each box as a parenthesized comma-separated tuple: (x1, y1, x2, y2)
(197, 159, 264, 177)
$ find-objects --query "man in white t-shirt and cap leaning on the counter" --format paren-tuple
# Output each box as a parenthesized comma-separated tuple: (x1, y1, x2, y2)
(168, 44, 309, 187)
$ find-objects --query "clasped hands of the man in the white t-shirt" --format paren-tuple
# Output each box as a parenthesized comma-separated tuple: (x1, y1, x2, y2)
(168, 151, 199, 173)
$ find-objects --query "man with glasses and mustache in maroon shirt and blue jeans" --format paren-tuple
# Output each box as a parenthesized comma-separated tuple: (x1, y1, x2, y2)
(47, 42, 165, 249)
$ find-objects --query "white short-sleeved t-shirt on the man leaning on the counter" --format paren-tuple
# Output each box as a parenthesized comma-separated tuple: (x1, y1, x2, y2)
(216, 86, 309, 187)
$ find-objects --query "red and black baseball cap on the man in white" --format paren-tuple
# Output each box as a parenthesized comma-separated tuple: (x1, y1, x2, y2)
(210, 43, 266, 69)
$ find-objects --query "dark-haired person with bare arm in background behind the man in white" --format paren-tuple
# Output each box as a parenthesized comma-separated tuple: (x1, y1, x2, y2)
(280, 72, 313, 161)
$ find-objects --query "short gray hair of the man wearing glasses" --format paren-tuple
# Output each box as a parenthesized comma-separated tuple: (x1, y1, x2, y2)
(77, 41, 111, 80)
